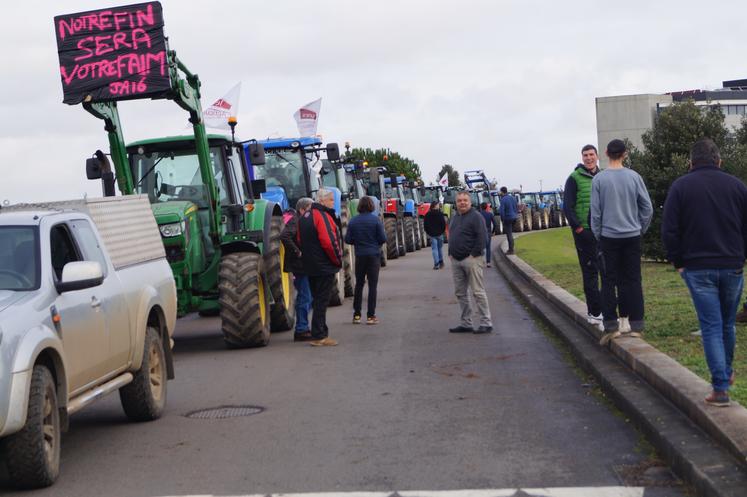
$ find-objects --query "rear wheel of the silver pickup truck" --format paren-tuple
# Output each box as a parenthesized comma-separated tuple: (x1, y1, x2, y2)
(119, 326, 166, 421)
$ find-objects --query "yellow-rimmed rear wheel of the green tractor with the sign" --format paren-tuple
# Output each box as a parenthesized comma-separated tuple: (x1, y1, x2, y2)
(263, 216, 296, 331)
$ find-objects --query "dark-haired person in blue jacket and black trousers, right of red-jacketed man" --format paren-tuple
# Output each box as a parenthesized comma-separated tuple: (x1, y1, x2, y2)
(345, 197, 386, 324)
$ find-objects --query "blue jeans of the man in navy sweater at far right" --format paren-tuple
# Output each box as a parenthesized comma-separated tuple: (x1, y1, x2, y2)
(682, 269, 744, 392)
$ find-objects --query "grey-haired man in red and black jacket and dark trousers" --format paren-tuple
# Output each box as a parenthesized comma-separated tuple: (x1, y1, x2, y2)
(297, 189, 342, 346)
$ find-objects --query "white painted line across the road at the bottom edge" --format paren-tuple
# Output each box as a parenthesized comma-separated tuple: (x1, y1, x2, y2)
(162, 487, 646, 497)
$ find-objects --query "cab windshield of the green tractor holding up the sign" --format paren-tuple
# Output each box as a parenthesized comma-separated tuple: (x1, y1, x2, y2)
(130, 147, 230, 209)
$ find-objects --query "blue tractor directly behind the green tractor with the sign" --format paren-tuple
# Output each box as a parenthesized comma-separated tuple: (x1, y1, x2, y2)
(244, 137, 352, 306)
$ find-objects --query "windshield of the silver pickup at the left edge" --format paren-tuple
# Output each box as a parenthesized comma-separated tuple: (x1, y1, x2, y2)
(0, 226, 41, 291)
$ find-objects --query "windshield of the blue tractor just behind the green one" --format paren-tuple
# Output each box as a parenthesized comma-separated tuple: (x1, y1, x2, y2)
(253, 149, 306, 205)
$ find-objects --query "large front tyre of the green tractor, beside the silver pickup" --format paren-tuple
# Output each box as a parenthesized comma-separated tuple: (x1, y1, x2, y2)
(218, 252, 270, 348)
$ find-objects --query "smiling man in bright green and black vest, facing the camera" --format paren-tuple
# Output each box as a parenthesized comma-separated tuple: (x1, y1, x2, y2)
(563, 145, 602, 329)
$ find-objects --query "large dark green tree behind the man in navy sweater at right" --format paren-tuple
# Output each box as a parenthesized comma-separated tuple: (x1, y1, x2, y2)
(630, 101, 732, 261)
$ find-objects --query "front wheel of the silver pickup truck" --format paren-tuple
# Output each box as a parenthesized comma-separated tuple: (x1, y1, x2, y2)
(0, 364, 61, 488)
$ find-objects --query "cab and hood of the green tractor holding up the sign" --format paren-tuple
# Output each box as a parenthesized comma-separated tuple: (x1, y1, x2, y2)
(126, 135, 261, 280)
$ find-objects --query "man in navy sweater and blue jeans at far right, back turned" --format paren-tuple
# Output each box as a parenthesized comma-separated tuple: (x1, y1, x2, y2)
(661, 139, 747, 407)
